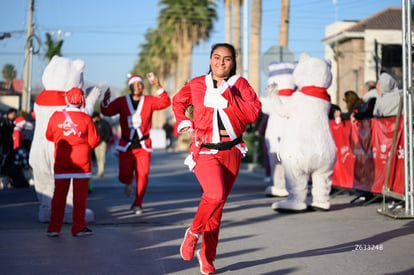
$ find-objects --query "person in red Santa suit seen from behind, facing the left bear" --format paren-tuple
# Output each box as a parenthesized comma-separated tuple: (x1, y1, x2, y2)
(46, 88, 100, 236)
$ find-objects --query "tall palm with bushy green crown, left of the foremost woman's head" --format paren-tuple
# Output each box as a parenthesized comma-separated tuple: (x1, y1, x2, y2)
(158, 0, 217, 97)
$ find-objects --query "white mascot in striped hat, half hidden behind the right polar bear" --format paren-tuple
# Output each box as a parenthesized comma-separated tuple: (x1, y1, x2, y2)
(262, 62, 295, 197)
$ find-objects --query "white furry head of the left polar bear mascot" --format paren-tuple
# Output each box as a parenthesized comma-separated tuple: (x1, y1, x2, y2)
(42, 55, 85, 91)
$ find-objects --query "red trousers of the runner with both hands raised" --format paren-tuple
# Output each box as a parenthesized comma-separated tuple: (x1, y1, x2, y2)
(118, 148, 151, 209)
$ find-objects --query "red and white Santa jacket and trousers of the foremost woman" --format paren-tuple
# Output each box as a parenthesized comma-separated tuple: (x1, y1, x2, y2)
(172, 74, 260, 262)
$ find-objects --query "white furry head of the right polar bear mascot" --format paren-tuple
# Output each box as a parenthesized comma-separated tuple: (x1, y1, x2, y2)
(293, 53, 332, 89)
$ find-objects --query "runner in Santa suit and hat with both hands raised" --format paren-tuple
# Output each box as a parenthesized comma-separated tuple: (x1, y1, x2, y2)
(101, 73, 171, 215)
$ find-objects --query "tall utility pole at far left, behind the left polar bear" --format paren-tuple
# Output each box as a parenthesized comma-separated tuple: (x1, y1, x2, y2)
(22, 0, 34, 113)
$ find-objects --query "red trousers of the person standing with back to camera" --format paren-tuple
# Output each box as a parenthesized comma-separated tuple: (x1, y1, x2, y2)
(48, 178, 89, 235)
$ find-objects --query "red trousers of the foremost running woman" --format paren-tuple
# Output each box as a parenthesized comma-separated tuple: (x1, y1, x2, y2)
(190, 147, 241, 261)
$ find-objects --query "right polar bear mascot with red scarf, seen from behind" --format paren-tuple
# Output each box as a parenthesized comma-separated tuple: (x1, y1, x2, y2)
(272, 53, 336, 213)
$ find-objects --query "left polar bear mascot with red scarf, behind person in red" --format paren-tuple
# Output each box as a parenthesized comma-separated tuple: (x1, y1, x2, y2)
(29, 56, 101, 223)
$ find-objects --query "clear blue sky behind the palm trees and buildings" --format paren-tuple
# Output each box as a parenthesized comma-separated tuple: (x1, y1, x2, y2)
(0, 0, 401, 94)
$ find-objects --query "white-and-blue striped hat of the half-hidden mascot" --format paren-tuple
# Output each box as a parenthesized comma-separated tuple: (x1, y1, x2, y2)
(267, 62, 296, 90)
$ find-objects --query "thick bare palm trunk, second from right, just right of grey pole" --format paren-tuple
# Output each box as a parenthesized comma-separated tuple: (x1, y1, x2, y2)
(249, 0, 262, 95)
